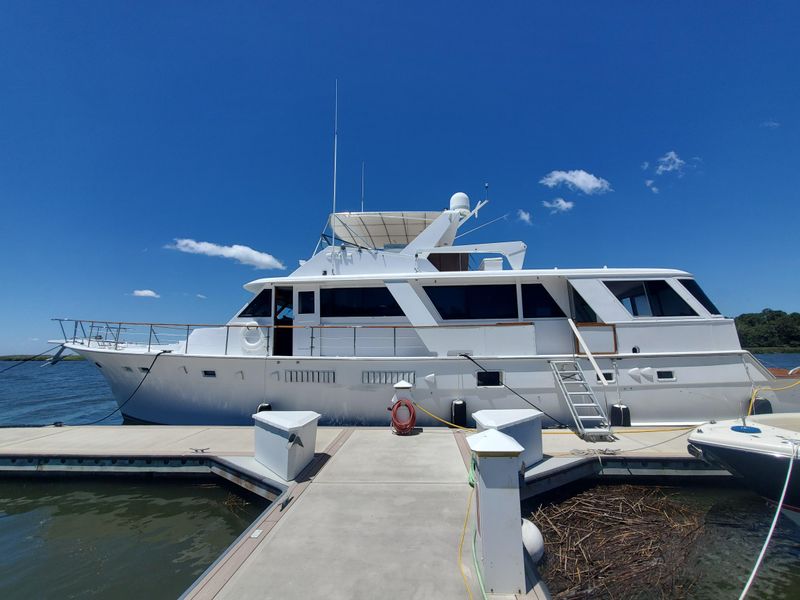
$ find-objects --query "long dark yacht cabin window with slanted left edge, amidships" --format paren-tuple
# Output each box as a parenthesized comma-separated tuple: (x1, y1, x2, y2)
(425, 285, 518, 319)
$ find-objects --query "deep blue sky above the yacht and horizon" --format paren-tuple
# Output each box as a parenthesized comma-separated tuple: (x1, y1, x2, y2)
(0, 0, 800, 353)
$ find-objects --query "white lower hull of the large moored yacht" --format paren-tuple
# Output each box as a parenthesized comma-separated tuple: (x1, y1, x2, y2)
(68, 345, 800, 426)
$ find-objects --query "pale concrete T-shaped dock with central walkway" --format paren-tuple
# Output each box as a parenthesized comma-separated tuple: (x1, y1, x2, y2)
(0, 426, 710, 599)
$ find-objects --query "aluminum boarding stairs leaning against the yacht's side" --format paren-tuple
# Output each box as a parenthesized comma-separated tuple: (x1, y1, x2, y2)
(550, 360, 612, 440)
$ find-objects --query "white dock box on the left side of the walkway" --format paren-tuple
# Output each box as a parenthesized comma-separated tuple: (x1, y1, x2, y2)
(253, 410, 320, 481)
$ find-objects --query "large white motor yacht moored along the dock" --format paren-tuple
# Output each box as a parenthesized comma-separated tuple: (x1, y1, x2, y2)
(53, 188, 800, 426)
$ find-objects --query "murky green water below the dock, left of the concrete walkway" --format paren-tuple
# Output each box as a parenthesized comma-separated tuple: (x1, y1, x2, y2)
(0, 478, 264, 600)
